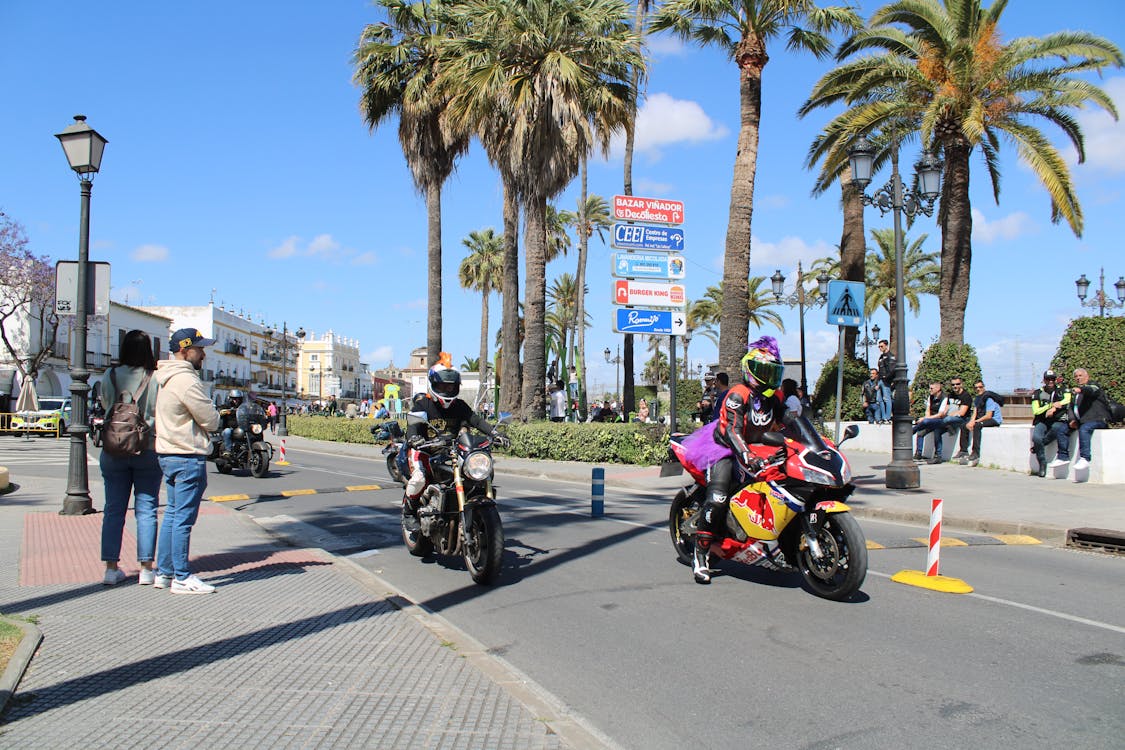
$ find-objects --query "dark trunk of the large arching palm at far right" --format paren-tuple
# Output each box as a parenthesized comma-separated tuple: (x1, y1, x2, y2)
(937, 138, 973, 344)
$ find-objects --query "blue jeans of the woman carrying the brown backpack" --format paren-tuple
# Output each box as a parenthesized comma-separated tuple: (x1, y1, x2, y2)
(98, 451, 161, 562)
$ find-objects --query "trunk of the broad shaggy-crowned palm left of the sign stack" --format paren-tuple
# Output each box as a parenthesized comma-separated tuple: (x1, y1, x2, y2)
(521, 196, 547, 418)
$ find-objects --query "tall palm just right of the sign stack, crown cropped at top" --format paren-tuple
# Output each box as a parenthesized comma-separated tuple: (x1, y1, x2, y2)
(651, 0, 860, 371)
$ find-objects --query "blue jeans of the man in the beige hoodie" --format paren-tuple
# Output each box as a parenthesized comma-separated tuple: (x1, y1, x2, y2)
(156, 455, 207, 580)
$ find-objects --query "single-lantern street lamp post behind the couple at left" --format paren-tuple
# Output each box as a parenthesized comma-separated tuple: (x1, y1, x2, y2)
(55, 115, 108, 516)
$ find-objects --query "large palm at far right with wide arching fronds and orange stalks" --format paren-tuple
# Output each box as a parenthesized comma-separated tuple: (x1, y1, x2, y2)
(802, 0, 1123, 343)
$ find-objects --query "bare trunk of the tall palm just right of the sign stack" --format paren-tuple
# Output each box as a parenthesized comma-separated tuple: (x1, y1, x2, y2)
(719, 36, 770, 372)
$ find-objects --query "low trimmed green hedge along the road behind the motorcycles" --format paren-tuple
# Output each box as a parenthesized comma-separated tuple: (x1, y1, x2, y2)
(288, 415, 668, 466)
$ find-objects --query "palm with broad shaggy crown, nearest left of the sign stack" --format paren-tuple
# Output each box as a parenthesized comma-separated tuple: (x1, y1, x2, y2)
(436, 0, 642, 414)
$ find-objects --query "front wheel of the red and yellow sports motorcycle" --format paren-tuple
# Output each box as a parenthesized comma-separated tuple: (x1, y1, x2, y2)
(797, 513, 867, 602)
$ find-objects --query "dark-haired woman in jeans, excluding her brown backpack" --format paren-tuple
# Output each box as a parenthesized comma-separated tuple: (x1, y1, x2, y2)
(98, 329, 161, 586)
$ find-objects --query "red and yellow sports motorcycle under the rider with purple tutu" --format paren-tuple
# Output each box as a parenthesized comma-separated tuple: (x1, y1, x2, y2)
(668, 417, 867, 600)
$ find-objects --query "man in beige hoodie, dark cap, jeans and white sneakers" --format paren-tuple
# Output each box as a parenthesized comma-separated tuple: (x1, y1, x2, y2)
(153, 328, 219, 594)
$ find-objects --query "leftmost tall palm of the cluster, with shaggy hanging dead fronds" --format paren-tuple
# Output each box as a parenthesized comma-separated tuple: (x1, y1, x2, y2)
(352, 0, 469, 363)
